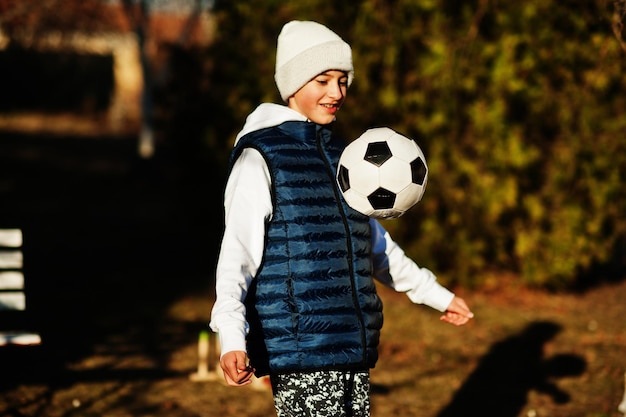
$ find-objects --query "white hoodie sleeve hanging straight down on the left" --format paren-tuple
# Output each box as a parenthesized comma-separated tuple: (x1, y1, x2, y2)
(210, 149, 272, 353)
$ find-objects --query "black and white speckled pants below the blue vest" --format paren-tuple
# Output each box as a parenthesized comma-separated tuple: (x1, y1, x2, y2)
(271, 370, 370, 417)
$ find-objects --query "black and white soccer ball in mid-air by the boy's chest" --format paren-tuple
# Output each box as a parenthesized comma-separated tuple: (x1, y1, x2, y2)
(337, 127, 428, 219)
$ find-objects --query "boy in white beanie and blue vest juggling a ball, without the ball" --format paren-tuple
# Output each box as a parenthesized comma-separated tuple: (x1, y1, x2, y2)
(211, 21, 473, 417)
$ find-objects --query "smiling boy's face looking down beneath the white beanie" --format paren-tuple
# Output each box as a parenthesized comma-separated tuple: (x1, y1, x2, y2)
(288, 70, 348, 125)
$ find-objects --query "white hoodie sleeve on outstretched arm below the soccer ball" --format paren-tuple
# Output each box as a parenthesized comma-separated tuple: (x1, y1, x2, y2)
(370, 219, 454, 311)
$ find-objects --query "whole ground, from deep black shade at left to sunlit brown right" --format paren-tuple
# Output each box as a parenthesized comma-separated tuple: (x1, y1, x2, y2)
(0, 131, 626, 417)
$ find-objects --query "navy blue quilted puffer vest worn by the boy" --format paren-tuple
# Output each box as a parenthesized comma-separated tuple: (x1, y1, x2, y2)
(231, 122, 382, 376)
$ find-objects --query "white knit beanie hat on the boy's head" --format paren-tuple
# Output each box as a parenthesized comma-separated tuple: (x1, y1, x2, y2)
(274, 20, 354, 101)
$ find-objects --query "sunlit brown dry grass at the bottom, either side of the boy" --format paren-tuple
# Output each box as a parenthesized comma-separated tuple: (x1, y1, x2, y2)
(0, 276, 626, 417)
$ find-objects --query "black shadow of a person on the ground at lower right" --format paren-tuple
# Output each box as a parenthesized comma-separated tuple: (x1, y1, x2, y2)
(437, 322, 586, 417)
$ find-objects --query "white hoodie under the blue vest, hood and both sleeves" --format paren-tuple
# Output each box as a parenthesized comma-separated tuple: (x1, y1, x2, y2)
(210, 103, 454, 354)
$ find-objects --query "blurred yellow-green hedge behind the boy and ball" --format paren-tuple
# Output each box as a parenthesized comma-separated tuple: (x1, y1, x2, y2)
(209, 0, 626, 288)
